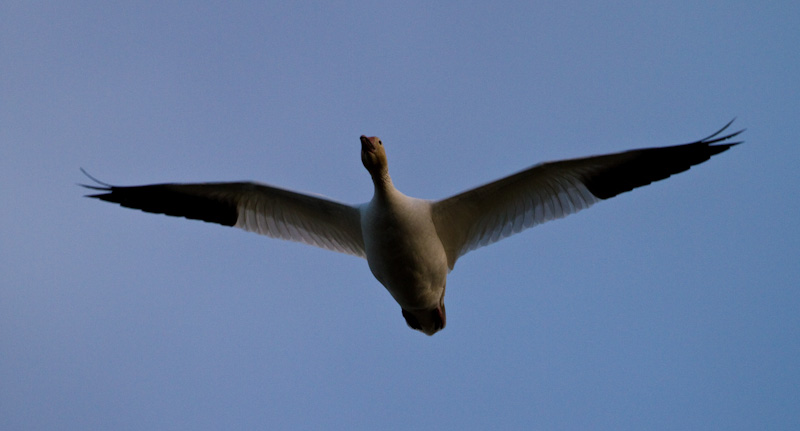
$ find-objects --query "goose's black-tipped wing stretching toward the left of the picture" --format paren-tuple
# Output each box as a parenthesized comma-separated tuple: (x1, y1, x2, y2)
(84, 171, 366, 257)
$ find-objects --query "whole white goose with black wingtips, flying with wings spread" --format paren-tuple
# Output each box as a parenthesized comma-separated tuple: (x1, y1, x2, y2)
(81, 121, 744, 335)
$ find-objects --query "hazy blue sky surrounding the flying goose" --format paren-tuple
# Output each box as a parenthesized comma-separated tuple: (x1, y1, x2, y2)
(0, 0, 800, 430)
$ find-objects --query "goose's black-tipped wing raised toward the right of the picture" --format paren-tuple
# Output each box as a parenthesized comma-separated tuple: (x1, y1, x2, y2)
(433, 121, 744, 269)
